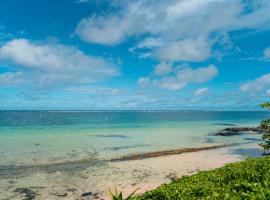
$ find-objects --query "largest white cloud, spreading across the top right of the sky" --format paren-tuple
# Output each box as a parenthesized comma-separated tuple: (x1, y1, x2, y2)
(75, 0, 270, 61)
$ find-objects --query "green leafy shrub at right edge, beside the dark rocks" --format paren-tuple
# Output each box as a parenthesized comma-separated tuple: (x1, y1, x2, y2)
(260, 103, 270, 154)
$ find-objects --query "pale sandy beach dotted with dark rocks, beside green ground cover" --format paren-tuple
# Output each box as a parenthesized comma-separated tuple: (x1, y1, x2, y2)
(0, 143, 259, 199)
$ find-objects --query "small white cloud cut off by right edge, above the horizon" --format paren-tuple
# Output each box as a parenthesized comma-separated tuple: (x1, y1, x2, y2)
(241, 73, 270, 92)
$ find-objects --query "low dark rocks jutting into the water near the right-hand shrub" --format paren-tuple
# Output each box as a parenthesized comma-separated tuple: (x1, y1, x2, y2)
(213, 127, 265, 136)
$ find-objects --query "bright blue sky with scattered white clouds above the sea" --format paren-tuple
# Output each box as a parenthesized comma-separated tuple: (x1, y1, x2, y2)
(0, 0, 270, 110)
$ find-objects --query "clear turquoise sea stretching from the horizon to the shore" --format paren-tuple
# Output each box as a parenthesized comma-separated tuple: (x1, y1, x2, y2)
(0, 111, 270, 166)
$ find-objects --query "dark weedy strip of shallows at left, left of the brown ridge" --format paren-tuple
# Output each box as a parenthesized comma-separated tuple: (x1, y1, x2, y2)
(0, 158, 107, 179)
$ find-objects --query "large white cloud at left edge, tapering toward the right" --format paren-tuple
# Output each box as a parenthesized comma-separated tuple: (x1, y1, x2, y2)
(0, 39, 118, 86)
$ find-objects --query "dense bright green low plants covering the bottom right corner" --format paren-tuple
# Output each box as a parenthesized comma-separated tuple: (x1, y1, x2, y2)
(133, 156, 270, 200)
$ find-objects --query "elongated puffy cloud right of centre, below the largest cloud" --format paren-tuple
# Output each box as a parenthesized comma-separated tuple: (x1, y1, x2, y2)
(138, 64, 218, 90)
